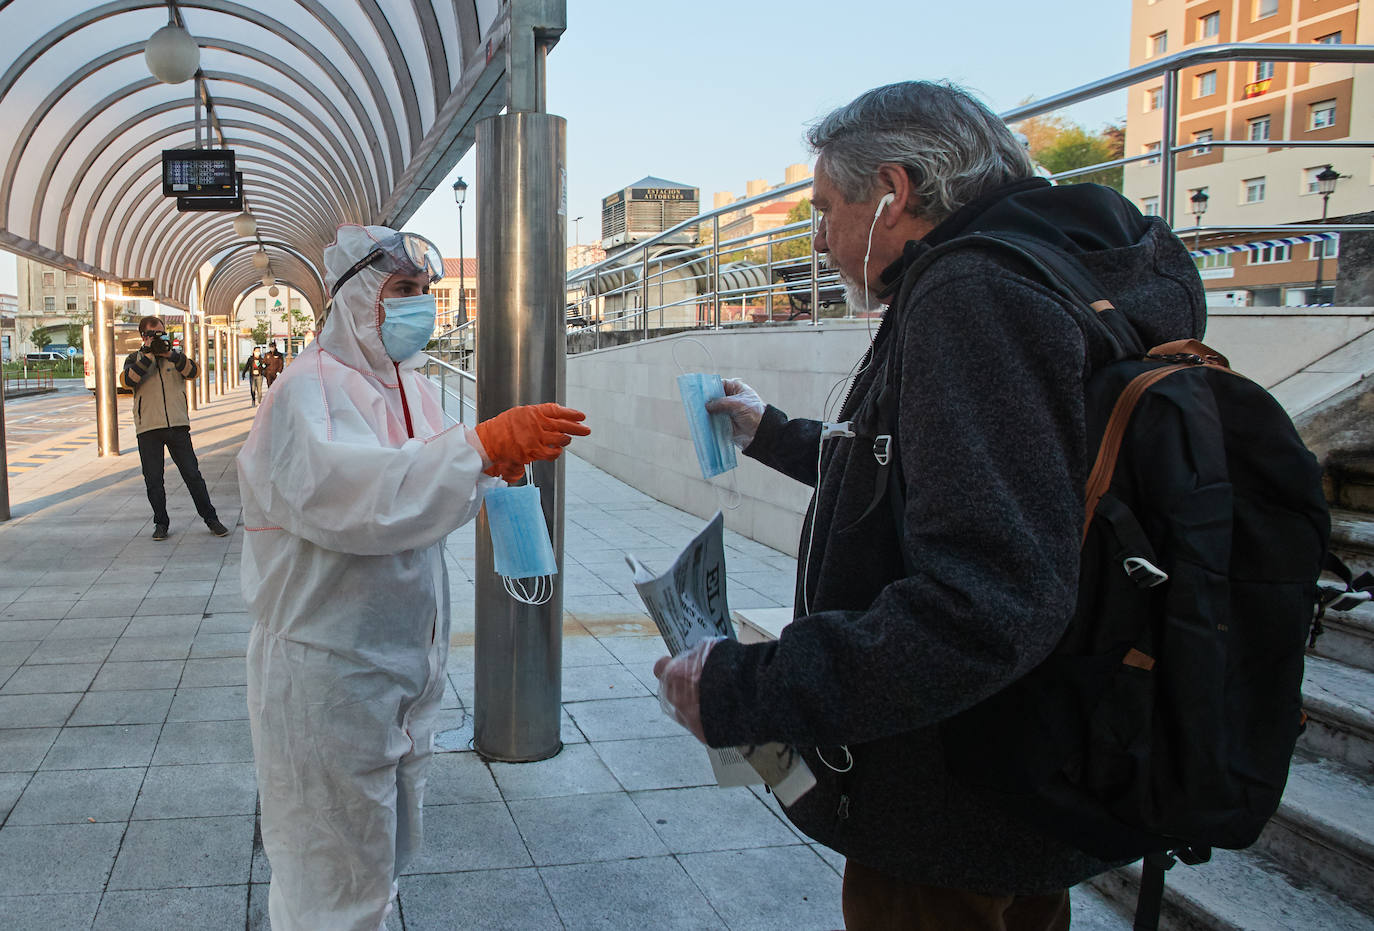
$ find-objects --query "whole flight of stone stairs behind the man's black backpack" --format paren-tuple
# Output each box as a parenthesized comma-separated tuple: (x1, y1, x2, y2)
(1090, 491, 1374, 931)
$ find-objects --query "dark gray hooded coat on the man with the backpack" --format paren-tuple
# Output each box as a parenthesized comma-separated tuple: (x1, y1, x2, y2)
(701, 183, 1205, 894)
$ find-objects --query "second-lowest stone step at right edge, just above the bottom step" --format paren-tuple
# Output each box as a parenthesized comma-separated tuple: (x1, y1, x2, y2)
(1254, 751, 1374, 915)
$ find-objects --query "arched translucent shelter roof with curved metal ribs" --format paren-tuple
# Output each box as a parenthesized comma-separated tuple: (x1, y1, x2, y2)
(0, 0, 563, 313)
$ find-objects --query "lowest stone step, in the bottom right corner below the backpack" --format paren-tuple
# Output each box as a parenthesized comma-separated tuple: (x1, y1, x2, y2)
(1090, 850, 1374, 931)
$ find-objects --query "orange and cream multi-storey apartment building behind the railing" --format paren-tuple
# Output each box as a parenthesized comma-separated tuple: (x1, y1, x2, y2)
(1124, 0, 1374, 306)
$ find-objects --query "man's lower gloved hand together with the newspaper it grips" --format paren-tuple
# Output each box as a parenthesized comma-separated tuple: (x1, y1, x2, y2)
(625, 511, 816, 805)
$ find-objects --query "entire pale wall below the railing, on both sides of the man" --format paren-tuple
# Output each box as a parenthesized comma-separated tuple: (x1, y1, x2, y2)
(567, 308, 1374, 555)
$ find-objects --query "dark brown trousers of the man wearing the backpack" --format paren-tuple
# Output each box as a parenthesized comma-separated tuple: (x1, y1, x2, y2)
(844, 860, 1069, 931)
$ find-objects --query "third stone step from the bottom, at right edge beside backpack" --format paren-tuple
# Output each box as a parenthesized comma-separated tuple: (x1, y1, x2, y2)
(1298, 654, 1374, 773)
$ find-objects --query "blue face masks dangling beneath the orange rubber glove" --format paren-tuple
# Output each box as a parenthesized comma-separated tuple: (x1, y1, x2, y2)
(486, 471, 558, 604)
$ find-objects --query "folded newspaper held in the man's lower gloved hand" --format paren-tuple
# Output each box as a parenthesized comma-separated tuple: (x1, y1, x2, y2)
(625, 511, 816, 805)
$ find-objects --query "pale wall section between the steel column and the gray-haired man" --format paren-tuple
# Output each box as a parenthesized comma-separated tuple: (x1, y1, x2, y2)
(567, 321, 877, 555)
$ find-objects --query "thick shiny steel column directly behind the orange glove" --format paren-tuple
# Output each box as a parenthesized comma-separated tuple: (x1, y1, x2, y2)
(473, 111, 567, 762)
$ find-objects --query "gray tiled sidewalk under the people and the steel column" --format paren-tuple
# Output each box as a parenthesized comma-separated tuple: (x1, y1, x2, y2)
(0, 391, 1124, 931)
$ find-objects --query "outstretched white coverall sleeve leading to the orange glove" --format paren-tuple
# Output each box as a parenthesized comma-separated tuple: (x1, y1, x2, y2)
(240, 382, 500, 556)
